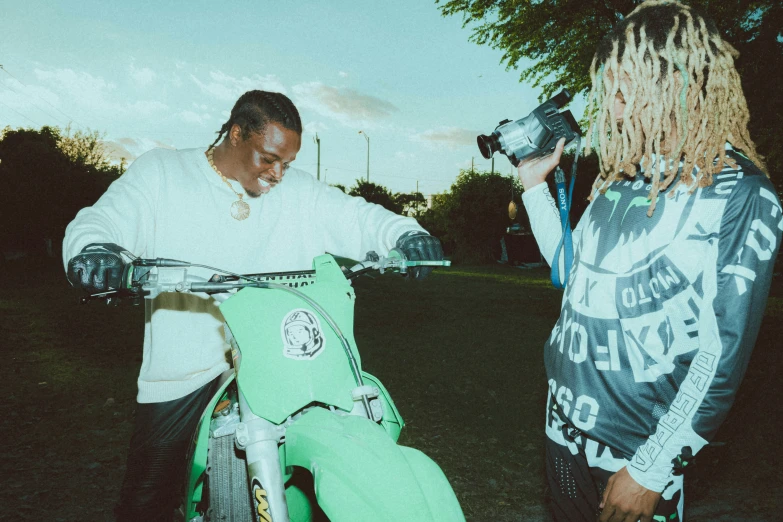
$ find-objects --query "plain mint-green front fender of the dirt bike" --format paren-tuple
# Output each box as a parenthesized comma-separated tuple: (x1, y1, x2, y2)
(285, 409, 465, 522)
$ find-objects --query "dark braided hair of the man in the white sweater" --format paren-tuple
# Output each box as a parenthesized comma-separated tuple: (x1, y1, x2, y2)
(209, 90, 302, 148)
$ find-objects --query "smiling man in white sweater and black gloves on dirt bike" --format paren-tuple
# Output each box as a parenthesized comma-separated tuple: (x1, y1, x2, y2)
(63, 91, 443, 522)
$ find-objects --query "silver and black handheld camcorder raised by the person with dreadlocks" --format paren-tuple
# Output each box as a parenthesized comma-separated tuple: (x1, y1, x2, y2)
(476, 89, 582, 167)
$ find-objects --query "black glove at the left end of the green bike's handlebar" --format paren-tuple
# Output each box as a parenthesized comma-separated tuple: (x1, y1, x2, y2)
(68, 243, 132, 294)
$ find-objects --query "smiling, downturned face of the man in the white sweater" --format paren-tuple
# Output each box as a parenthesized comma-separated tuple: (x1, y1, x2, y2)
(229, 122, 302, 198)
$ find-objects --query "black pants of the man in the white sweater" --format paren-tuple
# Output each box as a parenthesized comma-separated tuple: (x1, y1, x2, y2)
(114, 376, 222, 522)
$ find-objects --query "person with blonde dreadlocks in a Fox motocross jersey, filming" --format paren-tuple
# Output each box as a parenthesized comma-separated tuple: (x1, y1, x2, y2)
(519, 1, 783, 522)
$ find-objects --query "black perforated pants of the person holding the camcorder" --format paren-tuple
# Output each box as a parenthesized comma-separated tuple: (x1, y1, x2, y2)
(546, 437, 682, 522)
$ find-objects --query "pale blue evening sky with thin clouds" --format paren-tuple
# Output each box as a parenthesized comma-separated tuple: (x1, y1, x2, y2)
(0, 0, 583, 194)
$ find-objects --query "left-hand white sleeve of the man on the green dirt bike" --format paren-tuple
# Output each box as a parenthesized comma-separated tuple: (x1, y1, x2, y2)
(63, 147, 161, 270)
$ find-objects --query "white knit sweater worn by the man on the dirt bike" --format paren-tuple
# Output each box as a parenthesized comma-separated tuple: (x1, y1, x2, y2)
(63, 148, 423, 403)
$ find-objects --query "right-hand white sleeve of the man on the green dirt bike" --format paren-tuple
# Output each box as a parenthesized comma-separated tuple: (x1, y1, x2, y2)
(313, 182, 426, 259)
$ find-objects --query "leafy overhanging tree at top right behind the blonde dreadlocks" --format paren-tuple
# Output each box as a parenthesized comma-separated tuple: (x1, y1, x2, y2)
(435, 0, 783, 177)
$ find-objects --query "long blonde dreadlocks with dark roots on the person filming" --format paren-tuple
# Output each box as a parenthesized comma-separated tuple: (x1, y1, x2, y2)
(585, 0, 766, 216)
